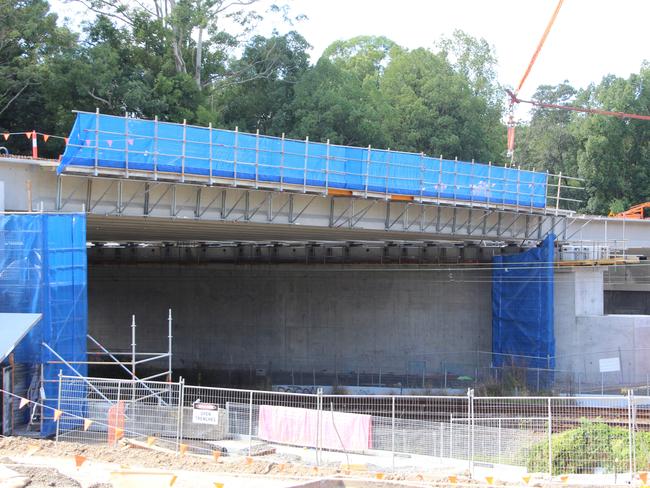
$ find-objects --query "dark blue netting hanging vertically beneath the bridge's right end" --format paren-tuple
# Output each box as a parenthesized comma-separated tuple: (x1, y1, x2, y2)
(492, 235, 555, 369)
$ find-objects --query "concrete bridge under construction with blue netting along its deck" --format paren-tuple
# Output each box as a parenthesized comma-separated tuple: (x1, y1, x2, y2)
(0, 113, 650, 412)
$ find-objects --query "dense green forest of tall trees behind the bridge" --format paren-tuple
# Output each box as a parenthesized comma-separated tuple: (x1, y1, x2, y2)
(0, 0, 650, 213)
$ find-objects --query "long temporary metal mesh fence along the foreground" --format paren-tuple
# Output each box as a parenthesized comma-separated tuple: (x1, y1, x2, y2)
(57, 376, 650, 475)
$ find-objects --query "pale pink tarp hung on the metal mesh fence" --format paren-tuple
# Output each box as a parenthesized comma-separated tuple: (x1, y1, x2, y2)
(257, 405, 372, 451)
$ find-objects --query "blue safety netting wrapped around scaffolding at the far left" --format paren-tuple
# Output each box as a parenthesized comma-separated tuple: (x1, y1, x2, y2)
(0, 214, 88, 437)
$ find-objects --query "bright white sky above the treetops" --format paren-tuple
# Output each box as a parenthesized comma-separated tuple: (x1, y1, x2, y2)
(52, 0, 650, 118)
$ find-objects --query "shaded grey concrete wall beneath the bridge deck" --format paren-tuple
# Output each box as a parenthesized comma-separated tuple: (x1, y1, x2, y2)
(89, 265, 492, 380)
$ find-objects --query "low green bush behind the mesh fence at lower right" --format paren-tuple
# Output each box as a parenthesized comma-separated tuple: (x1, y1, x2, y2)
(527, 419, 650, 475)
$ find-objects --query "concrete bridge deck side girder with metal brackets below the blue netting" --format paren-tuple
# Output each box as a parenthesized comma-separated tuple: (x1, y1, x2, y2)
(0, 156, 650, 252)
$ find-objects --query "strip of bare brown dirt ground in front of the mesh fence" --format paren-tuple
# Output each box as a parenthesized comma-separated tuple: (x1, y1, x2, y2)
(0, 436, 632, 488)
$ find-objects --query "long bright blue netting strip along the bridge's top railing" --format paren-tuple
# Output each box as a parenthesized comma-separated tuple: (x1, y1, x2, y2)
(58, 113, 547, 208)
